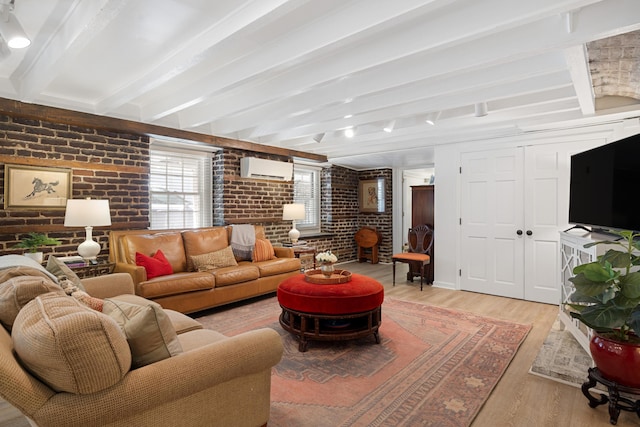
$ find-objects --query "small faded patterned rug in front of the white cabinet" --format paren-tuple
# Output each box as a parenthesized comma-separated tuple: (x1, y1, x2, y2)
(529, 320, 593, 387)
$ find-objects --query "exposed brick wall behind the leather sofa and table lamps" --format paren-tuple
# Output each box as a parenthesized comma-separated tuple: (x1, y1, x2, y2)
(0, 111, 391, 262)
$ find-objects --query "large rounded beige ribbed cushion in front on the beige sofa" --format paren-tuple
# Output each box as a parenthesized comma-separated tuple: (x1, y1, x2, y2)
(11, 292, 131, 394)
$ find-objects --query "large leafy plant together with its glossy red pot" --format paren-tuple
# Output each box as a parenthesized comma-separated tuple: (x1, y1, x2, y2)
(569, 231, 640, 388)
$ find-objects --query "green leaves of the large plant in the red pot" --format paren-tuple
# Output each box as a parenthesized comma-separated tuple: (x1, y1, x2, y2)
(569, 231, 640, 342)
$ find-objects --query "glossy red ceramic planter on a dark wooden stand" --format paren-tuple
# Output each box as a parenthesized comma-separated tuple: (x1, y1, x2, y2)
(589, 334, 640, 388)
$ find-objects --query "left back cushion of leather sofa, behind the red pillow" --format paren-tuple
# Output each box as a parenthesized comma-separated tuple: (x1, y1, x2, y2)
(120, 231, 187, 273)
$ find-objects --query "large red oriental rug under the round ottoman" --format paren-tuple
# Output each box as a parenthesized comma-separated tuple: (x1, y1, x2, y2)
(198, 298, 531, 427)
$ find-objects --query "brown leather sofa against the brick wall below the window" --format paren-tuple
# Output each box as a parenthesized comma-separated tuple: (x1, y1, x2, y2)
(109, 226, 300, 313)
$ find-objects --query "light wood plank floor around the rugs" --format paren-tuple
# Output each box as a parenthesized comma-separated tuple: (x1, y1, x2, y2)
(0, 263, 640, 427)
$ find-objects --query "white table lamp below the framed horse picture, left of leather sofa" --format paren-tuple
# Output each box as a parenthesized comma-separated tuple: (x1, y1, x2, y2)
(64, 198, 111, 261)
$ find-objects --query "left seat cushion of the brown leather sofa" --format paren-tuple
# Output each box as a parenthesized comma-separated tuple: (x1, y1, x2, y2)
(136, 271, 216, 299)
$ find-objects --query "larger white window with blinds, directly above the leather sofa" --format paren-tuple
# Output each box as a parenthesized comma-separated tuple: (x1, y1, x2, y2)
(149, 142, 212, 229)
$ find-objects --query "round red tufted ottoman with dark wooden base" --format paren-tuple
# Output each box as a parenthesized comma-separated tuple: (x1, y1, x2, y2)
(277, 274, 384, 351)
